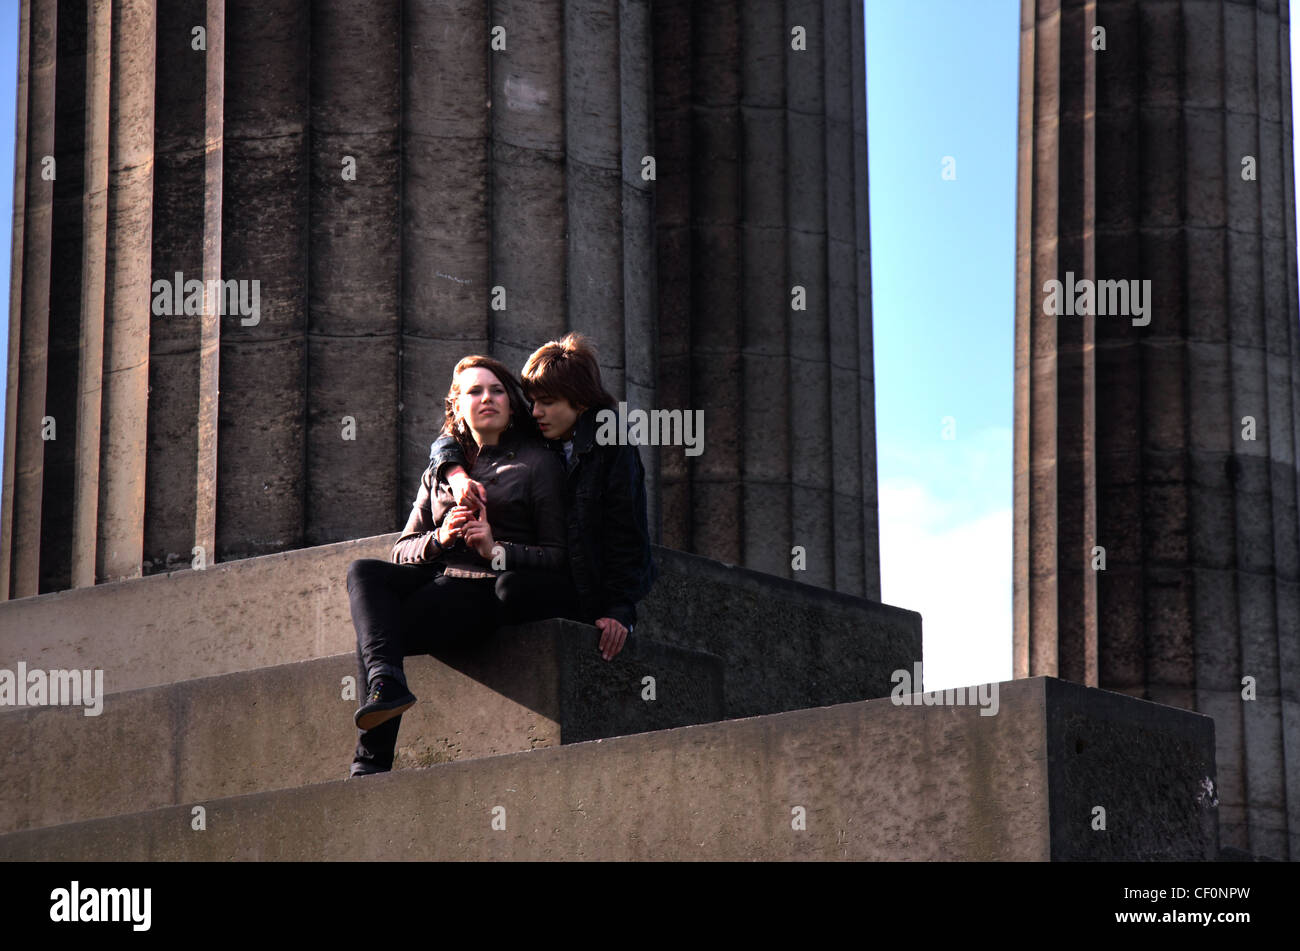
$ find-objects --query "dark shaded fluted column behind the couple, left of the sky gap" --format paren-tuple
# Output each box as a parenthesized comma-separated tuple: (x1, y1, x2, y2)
(654, 0, 880, 598)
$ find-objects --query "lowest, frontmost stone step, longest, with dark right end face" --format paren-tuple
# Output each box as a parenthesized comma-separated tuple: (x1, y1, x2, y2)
(0, 677, 1217, 861)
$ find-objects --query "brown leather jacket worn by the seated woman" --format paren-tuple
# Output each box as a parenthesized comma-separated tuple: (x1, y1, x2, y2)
(390, 430, 568, 578)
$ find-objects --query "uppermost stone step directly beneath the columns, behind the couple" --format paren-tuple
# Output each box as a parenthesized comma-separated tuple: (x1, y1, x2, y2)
(0, 533, 922, 717)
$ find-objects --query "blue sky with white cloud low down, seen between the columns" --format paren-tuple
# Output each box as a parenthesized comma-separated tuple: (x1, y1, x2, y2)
(0, 0, 1297, 689)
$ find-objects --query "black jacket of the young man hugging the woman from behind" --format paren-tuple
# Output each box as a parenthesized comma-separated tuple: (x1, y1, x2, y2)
(429, 407, 659, 628)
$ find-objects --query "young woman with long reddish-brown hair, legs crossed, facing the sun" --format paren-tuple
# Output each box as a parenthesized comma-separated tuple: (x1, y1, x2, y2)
(347, 356, 568, 776)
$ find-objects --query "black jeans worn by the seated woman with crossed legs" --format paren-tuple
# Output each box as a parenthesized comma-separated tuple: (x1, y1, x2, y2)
(347, 559, 577, 773)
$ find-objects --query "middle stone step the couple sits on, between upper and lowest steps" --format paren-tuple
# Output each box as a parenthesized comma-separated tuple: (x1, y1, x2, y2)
(0, 620, 722, 831)
